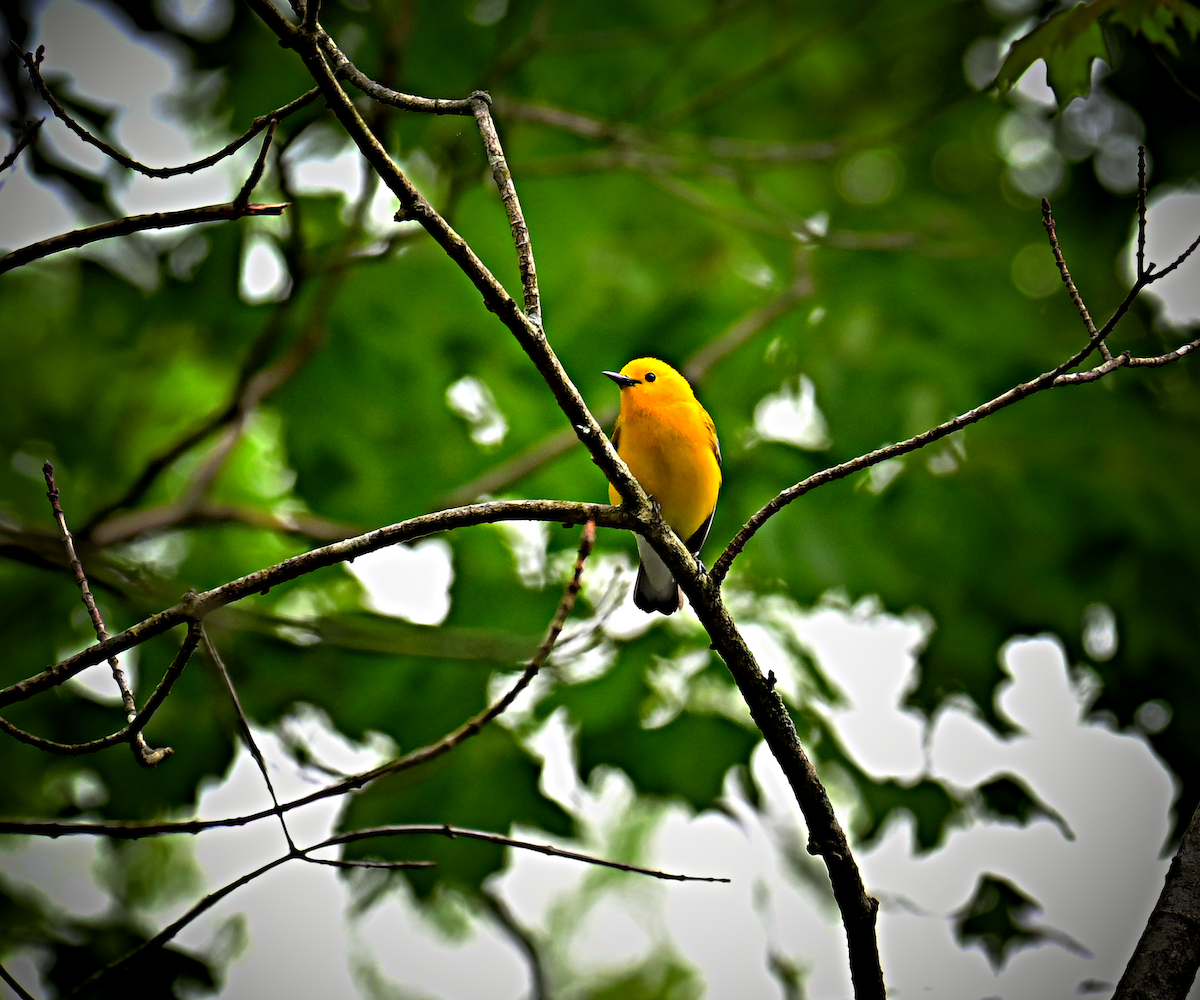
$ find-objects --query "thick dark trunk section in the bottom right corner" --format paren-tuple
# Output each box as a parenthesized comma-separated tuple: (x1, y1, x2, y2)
(1112, 809, 1200, 1000)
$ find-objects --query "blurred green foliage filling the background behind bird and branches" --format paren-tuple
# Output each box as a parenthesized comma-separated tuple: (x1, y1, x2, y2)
(0, 0, 1200, 996)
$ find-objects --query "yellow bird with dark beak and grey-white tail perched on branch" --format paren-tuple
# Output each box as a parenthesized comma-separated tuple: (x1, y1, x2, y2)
(605, 358, 721, 615)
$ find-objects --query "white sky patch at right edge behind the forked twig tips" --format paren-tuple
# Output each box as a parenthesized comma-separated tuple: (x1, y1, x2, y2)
(1122, 187, 1200, 327)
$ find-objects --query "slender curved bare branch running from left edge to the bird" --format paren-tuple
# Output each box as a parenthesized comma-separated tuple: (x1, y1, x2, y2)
(0, 501, 637, 708)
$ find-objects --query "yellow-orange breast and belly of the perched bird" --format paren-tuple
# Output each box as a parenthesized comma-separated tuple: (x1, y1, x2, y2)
(608, 393, 721, 541)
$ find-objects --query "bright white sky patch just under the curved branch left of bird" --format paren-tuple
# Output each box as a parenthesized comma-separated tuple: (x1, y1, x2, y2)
(346, 538, 454, 625)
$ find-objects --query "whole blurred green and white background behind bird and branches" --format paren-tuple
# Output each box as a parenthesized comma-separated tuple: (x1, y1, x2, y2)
(0, 0, 1200, 1000)
